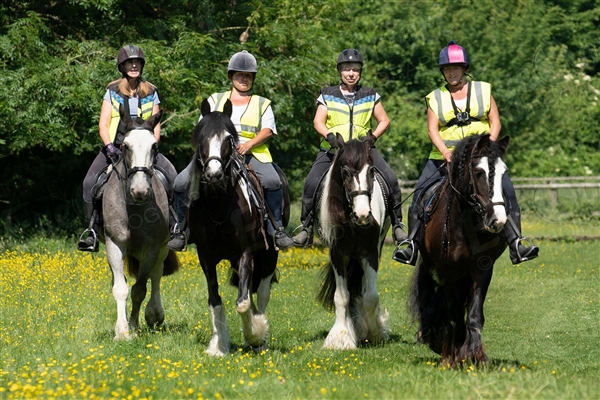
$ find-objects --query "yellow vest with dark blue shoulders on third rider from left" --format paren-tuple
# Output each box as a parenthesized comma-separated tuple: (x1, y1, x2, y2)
(321, 85, 377, 149)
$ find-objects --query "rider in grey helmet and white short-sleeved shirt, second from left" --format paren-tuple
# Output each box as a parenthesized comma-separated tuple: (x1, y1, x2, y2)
(167, 50, 294, 251)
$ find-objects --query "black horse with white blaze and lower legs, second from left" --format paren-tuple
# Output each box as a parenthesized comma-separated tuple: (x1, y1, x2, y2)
(188, 100, 289, 356)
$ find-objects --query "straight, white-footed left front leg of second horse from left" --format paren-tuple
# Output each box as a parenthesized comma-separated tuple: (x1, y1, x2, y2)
(200, 258, 229, 357)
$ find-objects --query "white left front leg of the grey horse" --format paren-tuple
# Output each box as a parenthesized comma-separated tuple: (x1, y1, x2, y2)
(106, 237, 134, 340)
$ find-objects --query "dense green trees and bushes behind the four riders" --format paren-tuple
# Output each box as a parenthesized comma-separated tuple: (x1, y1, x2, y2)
(0, 0, 600, 233)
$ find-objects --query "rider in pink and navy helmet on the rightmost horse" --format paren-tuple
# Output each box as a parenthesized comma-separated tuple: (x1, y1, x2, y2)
(393, 41, 539, 265)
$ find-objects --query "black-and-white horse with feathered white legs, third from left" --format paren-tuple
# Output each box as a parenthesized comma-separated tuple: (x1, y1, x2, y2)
(317, 133, 390, 349)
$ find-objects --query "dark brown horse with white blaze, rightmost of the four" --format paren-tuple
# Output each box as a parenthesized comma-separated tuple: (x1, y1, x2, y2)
(410, 134, 509, 367)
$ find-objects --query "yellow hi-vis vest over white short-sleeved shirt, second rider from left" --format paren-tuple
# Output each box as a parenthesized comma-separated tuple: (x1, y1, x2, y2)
(210, 90, 273, 164)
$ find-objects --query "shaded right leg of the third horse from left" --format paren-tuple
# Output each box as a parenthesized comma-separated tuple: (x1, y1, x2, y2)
(362, 259, 389, 343)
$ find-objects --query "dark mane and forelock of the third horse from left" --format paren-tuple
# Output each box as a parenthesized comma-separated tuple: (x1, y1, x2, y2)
(327, 140, 373, 224)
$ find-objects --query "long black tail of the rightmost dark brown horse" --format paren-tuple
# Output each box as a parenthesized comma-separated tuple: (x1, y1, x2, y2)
(409, 259, 447, 354)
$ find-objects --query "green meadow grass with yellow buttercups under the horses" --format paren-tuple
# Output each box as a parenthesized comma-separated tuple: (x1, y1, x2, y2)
(0, 240, 600, 399)
